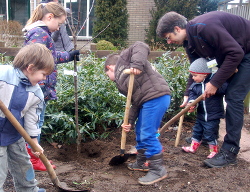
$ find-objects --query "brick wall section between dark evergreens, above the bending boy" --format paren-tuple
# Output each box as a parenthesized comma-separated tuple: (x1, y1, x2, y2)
(127, 0, 154, 45)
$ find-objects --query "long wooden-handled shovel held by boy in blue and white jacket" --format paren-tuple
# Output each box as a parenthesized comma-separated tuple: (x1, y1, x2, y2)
(0, 100, 90, 192)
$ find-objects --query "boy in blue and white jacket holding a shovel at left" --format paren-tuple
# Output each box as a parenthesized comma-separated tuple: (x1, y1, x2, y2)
(0, 43, 54, 192)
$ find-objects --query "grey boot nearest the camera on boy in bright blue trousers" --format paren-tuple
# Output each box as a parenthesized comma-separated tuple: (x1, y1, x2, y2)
(138, 153, 167, 185)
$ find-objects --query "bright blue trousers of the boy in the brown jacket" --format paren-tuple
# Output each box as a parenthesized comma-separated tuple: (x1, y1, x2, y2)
(135, 95, 171, 158)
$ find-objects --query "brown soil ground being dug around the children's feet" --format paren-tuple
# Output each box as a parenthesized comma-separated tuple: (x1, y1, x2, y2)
(2, 115, 250, 192)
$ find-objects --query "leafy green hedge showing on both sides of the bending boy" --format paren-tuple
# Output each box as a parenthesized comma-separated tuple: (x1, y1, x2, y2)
(42, 52, 189, 143)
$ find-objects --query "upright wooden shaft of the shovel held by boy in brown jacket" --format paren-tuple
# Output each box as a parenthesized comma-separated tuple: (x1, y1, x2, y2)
(121, 73, 135, 154)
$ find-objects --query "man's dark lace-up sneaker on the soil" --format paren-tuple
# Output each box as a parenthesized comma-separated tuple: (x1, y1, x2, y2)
(204, 149, 237, 168)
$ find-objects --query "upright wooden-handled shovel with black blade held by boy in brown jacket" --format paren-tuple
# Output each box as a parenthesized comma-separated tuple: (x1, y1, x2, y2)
(109, 70, 135, 166)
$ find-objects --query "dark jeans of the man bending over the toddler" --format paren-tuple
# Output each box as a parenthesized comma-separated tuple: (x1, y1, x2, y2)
(222, 53, 250, 154)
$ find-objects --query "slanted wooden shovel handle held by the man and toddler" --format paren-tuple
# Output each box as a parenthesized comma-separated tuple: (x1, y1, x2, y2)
(159, 95, 203, 136)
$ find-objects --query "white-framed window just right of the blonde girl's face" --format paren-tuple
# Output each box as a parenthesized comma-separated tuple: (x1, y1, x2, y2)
(64, 0, 94, 39)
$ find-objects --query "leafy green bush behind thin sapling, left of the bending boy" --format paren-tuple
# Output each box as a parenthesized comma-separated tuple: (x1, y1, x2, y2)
(42, 55, 126, 142)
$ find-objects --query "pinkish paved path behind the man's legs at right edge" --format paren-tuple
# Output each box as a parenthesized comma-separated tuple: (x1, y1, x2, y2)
(219, 119, 250, 162)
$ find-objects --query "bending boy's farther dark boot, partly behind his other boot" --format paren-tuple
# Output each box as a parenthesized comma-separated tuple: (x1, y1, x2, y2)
(127, 149, 149, 171)
